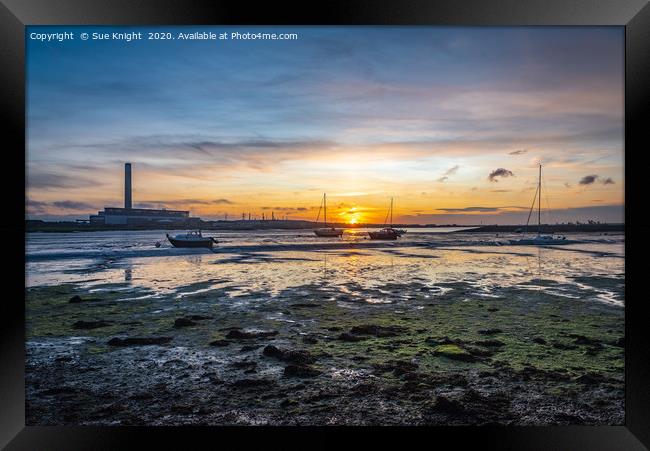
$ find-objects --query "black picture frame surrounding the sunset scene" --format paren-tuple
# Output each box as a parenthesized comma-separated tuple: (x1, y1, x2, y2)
(0, 0, 650, 450)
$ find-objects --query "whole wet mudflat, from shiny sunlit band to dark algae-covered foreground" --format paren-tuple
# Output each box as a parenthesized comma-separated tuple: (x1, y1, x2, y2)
(26, 235, 624, 425)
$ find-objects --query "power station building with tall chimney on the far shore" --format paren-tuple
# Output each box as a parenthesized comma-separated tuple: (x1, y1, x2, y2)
(90, 163, 195, 225)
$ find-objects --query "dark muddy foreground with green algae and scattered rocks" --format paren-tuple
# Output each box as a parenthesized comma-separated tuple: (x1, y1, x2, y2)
(26, 277, 624, 425)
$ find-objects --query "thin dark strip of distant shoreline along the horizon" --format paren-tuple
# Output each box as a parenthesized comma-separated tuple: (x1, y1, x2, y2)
(25, 220, 625, 233)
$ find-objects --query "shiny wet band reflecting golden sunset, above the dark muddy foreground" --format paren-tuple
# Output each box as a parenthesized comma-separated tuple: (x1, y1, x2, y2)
(27, 237, 624, 308)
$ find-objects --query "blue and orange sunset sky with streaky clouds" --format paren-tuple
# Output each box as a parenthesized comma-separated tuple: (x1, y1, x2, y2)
(26, 26, 625, 224)
